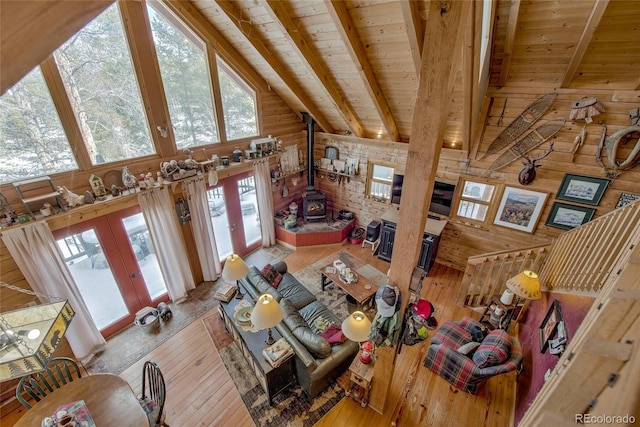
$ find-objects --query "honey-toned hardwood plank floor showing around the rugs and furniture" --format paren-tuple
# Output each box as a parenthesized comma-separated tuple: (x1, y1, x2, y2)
(5, 244, 515, 427)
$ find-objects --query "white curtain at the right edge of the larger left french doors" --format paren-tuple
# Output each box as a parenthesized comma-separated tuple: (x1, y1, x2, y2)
(138, 187, 195, 302)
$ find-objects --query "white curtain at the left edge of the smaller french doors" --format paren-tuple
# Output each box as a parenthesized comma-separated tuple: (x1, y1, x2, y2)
(182, 178, 222, 281)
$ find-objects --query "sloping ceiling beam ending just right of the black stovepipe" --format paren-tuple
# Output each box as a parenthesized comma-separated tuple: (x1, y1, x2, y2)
(216, 0, 333, 133)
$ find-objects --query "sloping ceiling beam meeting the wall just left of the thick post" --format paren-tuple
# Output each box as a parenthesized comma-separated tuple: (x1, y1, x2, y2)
(325, 0, 400, 141)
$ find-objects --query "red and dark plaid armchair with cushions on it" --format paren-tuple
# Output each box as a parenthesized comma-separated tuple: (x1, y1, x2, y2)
(424, 317, 522, 394)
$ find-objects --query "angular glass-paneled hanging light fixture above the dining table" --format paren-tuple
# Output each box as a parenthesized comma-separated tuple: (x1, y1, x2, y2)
(0, 300, 75, 381)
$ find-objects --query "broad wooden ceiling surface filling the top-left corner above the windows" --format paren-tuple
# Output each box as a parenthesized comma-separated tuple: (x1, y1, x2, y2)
(0, 0, 114, 94)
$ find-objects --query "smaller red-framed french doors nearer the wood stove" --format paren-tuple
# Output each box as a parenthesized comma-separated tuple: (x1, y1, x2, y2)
(207, 172, 262, 261)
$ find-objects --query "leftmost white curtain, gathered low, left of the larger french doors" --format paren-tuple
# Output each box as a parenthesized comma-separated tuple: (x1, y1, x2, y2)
(2, 221, 106, 359)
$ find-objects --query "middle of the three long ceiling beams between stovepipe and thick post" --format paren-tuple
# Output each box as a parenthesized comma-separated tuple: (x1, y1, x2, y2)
(264, 0, 365, 138)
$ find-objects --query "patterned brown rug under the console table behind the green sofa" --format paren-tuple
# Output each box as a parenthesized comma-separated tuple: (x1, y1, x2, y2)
(202, 313, 346, 427)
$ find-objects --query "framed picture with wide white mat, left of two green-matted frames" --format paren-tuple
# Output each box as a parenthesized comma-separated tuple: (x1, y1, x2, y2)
(493, 186, 548, 233)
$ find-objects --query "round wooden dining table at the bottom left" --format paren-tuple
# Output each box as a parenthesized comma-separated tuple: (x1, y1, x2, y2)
(15, 374, 149, 427)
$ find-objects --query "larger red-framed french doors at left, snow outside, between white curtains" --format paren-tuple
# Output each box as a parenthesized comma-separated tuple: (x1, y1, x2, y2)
(54, 206, 169, 338)
